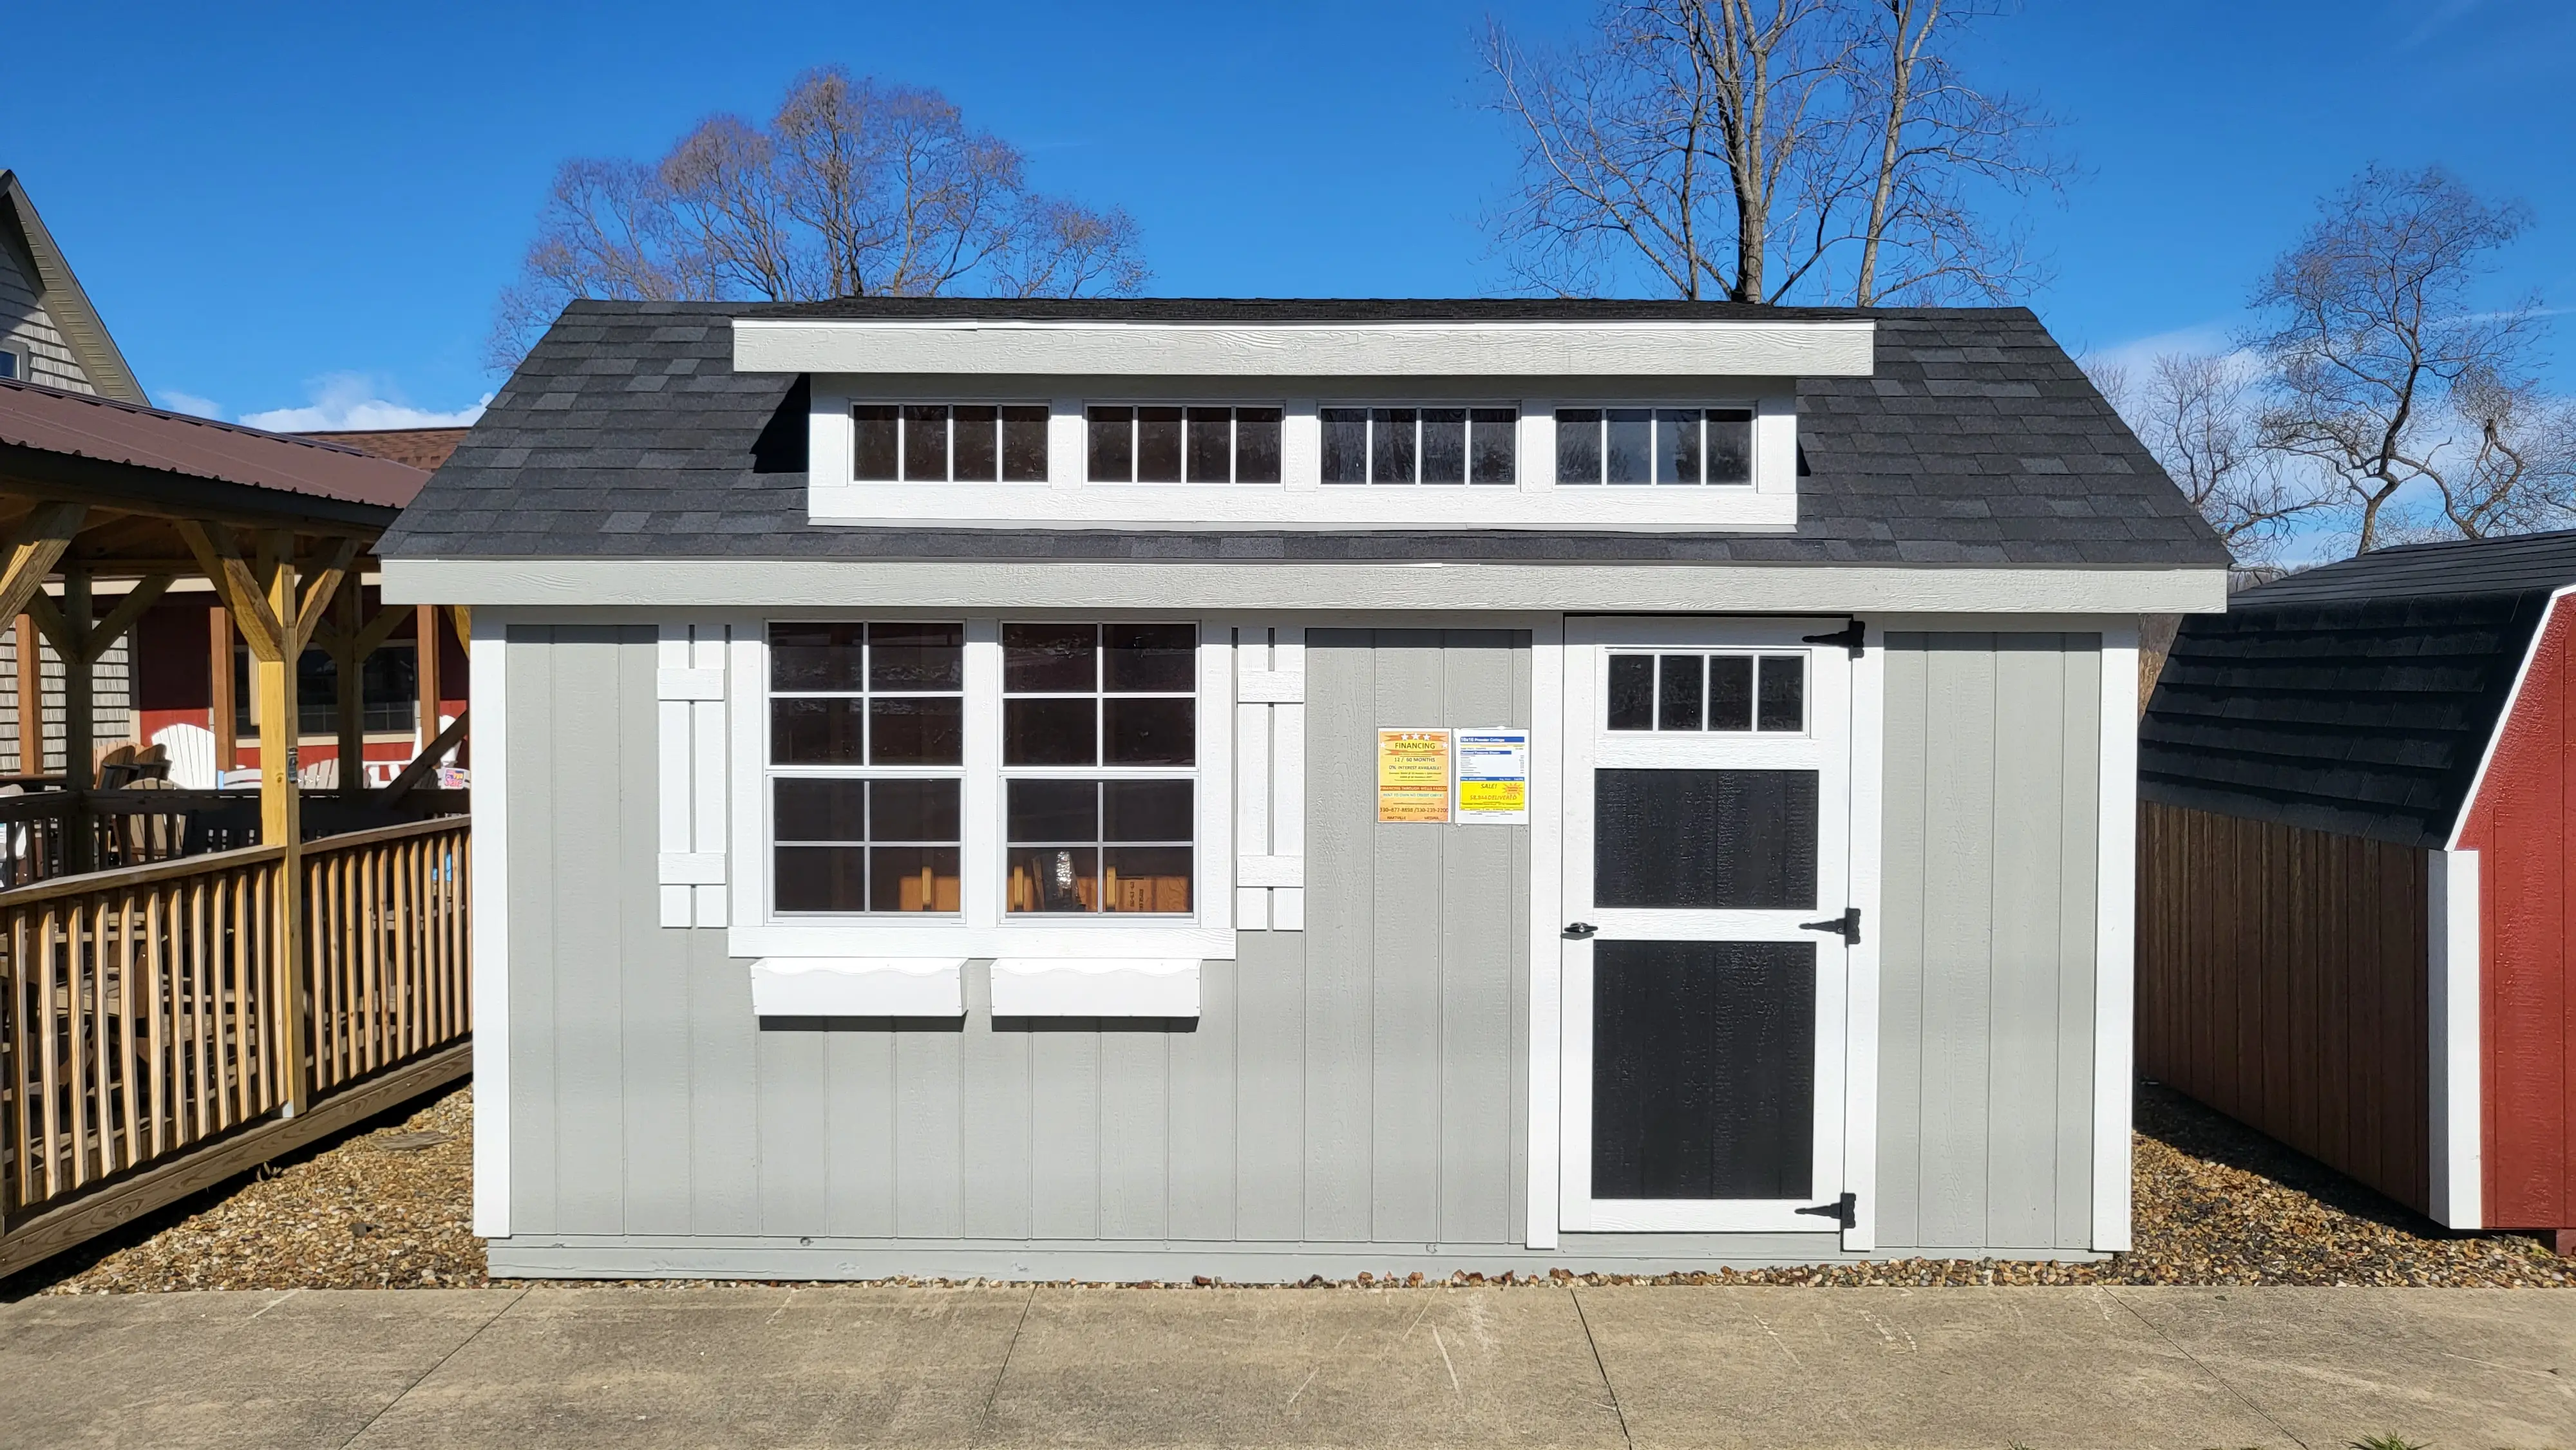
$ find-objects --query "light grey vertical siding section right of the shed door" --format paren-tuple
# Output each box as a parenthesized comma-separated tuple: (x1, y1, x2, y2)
(1878, 634, 2102, 1249)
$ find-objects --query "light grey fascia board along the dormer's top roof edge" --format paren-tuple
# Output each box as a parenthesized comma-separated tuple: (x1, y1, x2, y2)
(734, 317, 1875, 379)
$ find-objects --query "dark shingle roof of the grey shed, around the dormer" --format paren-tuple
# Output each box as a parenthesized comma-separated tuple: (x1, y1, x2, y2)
(379, 299, 2226, 569)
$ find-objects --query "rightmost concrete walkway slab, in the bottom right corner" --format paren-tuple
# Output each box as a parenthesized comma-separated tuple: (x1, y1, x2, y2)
(2112, 1288, 2576, 1447)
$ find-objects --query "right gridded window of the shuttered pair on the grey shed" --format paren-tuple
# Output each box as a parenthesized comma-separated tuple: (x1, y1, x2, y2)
(1002, 623, 1198, 917)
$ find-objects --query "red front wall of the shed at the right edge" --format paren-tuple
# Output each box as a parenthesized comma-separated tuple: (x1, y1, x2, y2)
(2460, 600, 2576, 1229)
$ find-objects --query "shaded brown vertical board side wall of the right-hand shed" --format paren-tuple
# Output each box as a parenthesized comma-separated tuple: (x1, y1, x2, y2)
(2138, 801, 2432, 1210)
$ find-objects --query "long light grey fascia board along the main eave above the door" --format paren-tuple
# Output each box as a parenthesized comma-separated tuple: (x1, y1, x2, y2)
(384, 559, 2228, 616)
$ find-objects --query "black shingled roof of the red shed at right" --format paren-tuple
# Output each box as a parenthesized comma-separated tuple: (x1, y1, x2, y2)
(2138, 531, 2576, 847)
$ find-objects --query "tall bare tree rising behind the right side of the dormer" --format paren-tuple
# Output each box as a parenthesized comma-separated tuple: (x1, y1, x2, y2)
(1484, 0, 2058, 304)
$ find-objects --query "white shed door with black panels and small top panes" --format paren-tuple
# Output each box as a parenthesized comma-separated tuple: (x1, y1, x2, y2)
(1561, 618, 1862, 1231)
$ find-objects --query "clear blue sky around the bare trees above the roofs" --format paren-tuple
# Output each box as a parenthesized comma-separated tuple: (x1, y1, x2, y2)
(0, 0, 2576, 428)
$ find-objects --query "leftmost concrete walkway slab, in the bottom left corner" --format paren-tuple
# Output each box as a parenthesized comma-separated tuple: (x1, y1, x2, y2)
(0, 1288, 520, 1450)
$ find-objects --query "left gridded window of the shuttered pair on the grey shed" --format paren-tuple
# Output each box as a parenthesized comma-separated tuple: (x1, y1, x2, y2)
(770, 623, 966, 914)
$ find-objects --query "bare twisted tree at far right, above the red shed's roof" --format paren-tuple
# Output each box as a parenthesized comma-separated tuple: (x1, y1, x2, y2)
(2251, 167, 2576, 554)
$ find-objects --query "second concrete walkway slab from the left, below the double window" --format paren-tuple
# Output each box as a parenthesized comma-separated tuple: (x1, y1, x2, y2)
(353, 1288, 1028, 1450)
